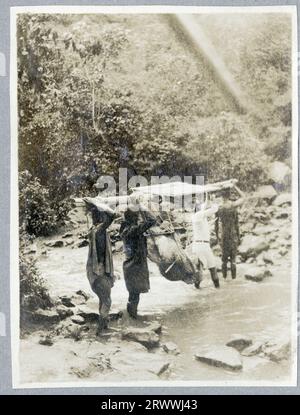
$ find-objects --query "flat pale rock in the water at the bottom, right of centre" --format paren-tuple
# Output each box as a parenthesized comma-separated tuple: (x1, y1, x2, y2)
(195, 346, 243, 371)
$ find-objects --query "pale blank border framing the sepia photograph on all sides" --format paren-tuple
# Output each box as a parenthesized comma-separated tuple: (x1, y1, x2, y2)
(5, 5, 298, 389)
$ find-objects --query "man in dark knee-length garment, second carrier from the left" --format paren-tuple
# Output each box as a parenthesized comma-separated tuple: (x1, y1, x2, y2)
(120, 204, 156, 318)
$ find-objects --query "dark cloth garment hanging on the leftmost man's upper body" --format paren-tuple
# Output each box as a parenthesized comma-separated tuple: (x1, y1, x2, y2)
(86, 213, 114, 288)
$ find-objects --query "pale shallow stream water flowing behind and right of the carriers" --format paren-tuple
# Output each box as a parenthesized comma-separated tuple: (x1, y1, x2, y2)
(32, 242, 291, 384)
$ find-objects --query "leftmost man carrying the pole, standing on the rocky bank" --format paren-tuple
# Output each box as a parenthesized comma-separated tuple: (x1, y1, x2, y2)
(84, 198, 115, 333)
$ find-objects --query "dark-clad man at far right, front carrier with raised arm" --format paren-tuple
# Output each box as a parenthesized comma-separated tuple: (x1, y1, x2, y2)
(215, 186, 245, 279)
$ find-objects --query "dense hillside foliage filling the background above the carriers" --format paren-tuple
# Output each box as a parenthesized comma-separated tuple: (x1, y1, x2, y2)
(18, 14, 291, 235)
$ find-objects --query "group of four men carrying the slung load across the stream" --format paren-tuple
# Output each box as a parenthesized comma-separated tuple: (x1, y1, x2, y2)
(85, 187, 243, 332)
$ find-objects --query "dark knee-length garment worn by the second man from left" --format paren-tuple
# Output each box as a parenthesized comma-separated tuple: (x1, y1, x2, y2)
(120, 211, 156, 294)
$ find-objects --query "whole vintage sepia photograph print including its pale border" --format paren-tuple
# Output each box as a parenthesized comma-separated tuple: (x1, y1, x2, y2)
(11, 6, 298, 388)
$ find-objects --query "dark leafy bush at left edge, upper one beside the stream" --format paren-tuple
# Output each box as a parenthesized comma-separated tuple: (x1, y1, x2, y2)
(19, 171, 57, 236)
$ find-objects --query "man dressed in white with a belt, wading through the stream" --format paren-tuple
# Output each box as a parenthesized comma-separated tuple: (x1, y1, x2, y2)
(192, 196, 220, 288)
